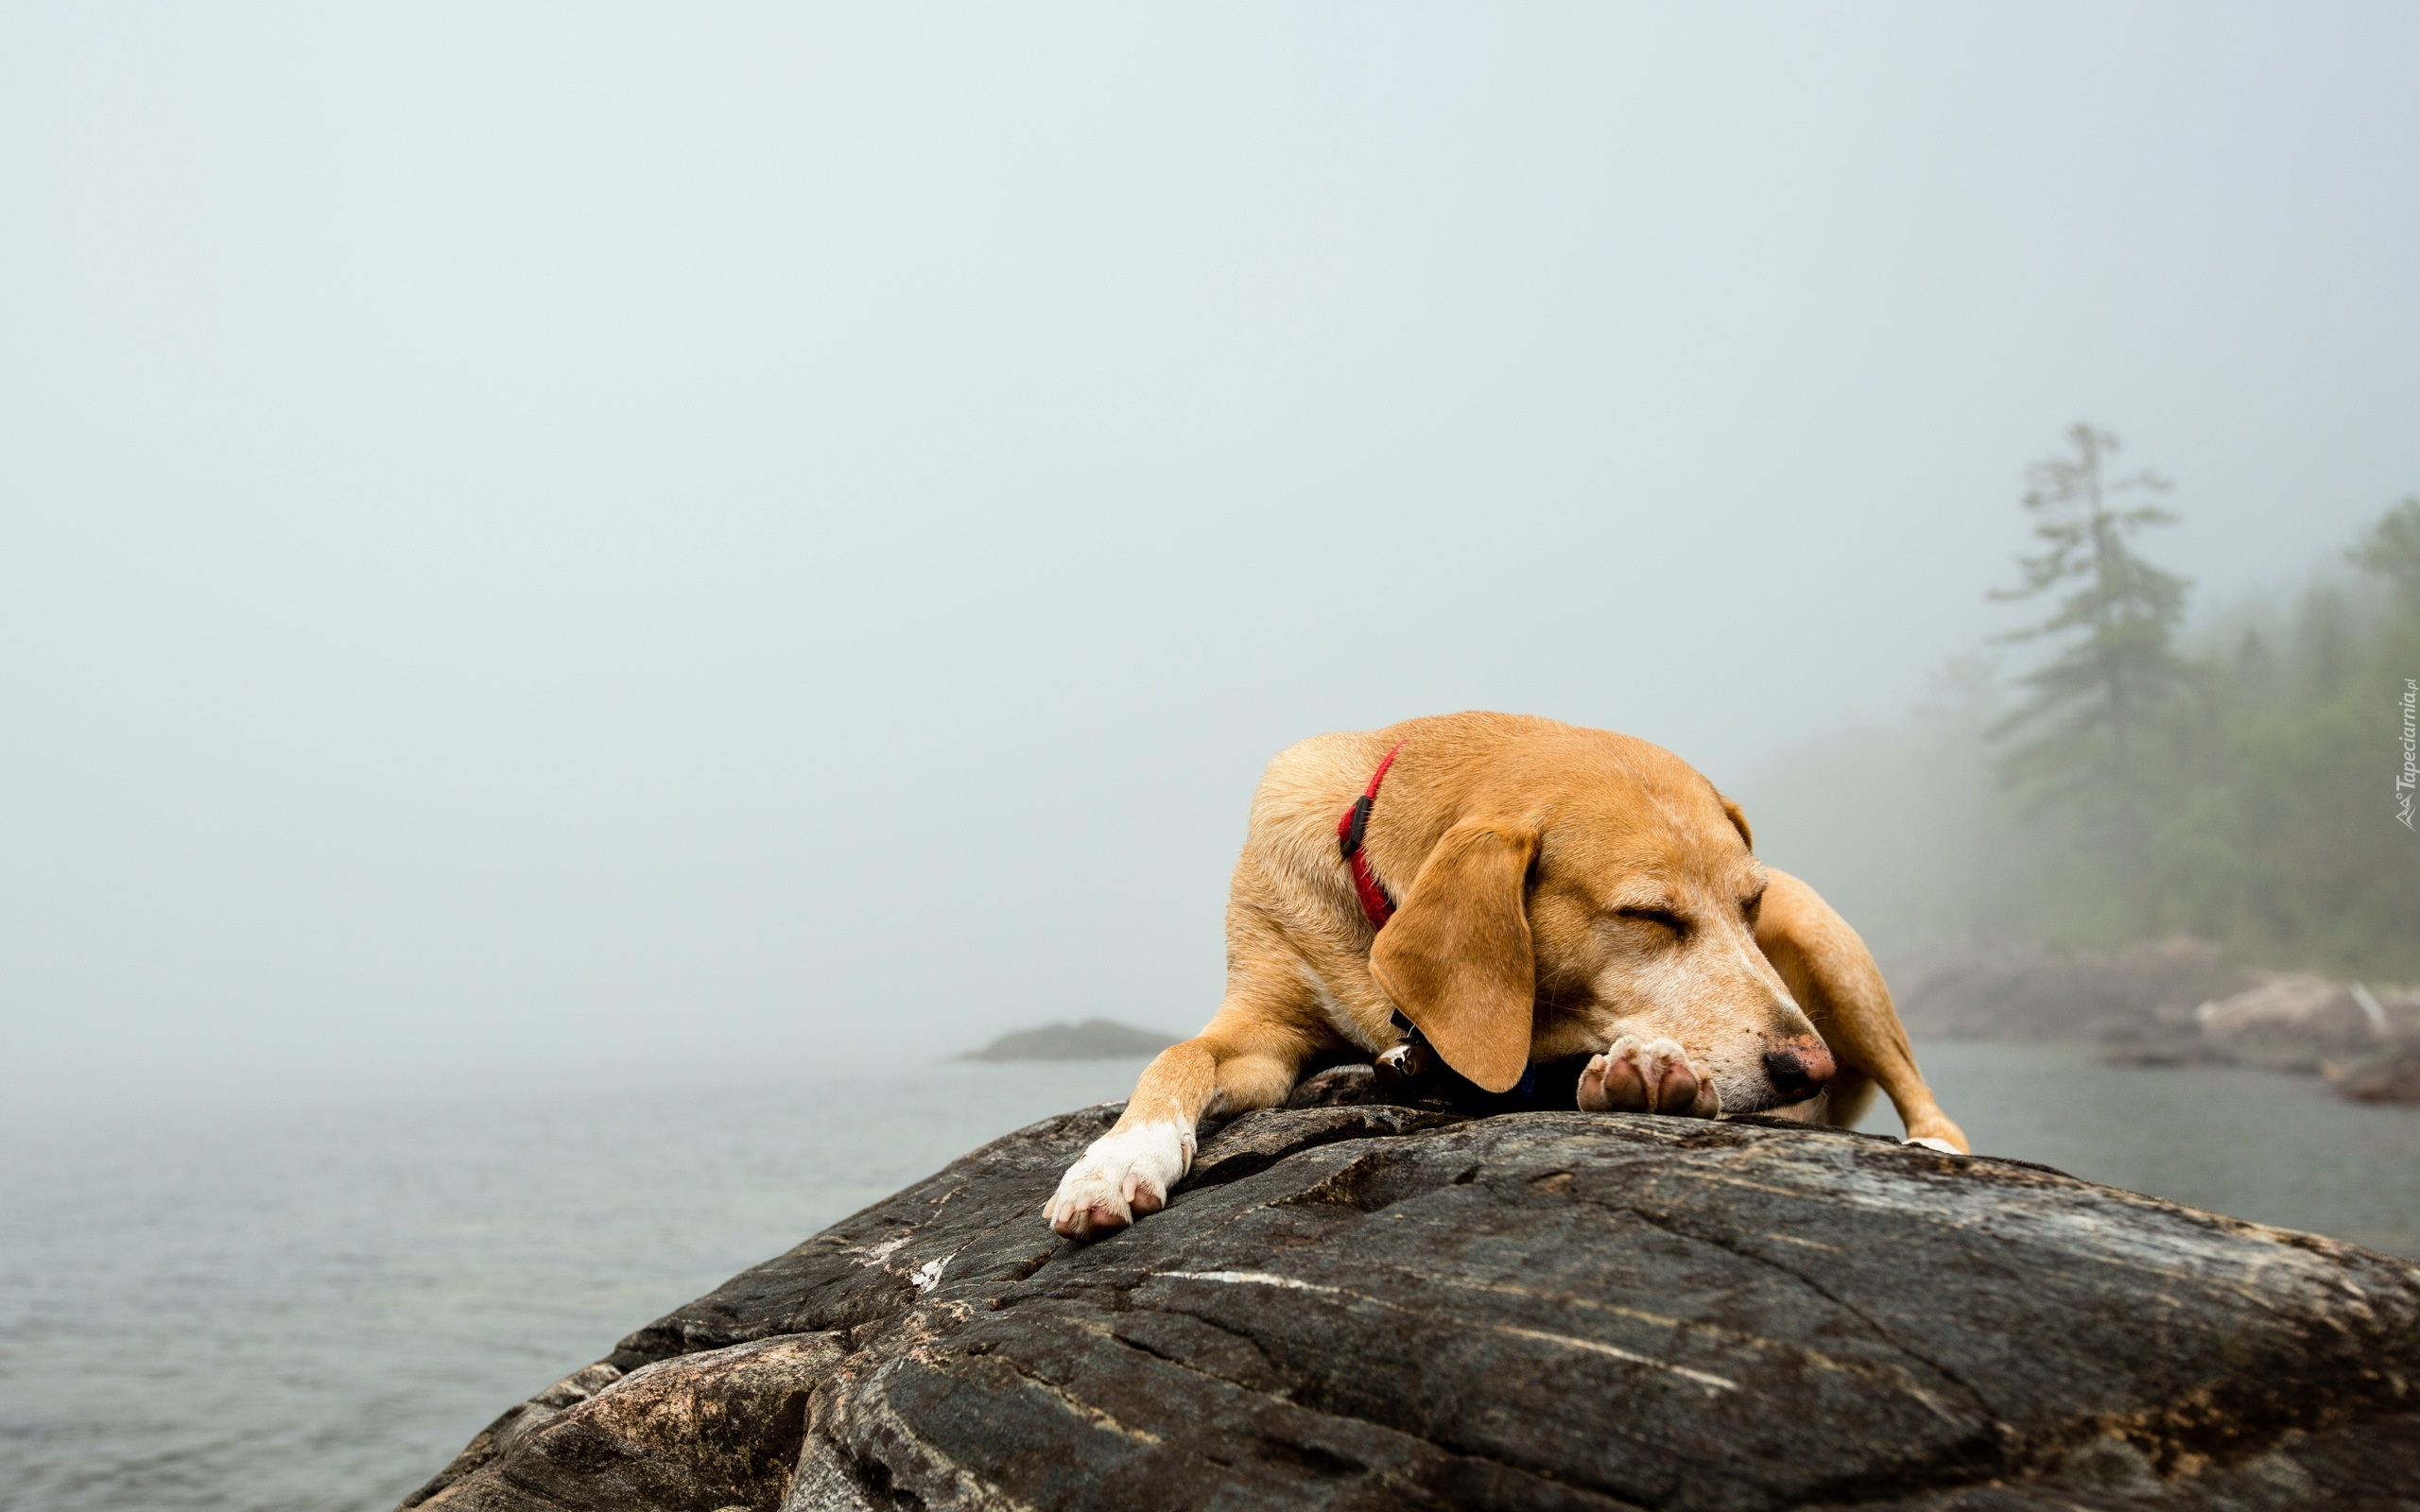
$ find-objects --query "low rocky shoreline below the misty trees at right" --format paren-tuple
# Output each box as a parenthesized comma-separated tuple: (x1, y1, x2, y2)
(1893, 936, 2420, 1103)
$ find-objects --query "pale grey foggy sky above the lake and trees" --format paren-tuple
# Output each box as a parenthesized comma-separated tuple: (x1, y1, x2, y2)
(0, 5, 2420, 1108)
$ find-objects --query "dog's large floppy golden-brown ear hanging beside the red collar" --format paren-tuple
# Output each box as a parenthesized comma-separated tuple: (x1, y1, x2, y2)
(1370, 822, 1537, 1091)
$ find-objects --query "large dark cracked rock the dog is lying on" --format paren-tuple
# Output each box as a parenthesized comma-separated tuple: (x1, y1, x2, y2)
(405, 1103, 2420, 1512)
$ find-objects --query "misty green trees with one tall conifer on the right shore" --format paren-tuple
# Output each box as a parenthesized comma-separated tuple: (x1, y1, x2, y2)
(1750, 423, 2420, 982)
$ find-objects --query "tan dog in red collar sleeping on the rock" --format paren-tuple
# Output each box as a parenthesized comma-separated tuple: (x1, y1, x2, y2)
(1047, 713, 1967, 1239)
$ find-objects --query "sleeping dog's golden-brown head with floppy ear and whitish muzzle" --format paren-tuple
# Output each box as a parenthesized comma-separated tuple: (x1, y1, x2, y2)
(1370, 730, 1832, 1113)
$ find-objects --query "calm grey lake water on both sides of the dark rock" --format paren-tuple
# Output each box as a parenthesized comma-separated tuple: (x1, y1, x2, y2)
(0, 1045, 2420, 1512)
